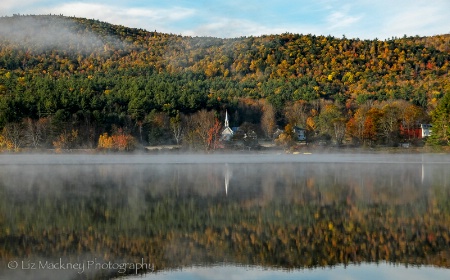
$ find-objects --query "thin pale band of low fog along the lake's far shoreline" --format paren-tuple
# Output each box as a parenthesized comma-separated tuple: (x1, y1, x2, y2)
(0, 153, 450, 165)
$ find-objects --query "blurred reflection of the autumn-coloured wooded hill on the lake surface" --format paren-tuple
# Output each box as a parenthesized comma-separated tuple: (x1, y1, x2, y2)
(0, 163, 450, 277)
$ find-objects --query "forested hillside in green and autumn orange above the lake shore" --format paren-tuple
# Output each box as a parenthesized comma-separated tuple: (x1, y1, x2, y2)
(0, 15, 450, 150)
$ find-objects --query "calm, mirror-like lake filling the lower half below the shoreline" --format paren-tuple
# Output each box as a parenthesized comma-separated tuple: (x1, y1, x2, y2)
(0, 154, 450, 279)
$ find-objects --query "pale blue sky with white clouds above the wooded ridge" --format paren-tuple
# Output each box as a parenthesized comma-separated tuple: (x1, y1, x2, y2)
(0, 0, 450, 40)
